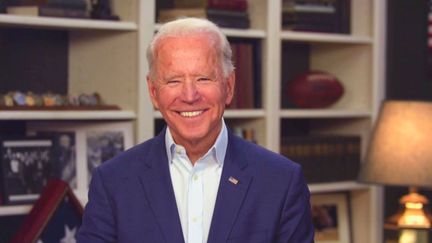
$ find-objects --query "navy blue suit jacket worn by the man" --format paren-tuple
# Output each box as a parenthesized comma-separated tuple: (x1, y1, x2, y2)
(77, 132, 314, 243)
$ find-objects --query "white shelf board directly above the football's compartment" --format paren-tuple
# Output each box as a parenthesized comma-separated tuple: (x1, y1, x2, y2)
(280, 31, 372, 45)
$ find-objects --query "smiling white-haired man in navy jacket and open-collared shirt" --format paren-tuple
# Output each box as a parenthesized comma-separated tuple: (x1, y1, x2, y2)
(78, 18, 313, 243)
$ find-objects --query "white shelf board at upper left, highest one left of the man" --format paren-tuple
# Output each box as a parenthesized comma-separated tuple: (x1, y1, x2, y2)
(0, 14, 138, 31)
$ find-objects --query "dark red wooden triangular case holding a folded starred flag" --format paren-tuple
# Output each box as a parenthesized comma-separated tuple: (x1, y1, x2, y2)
(11, 179, 83, 243)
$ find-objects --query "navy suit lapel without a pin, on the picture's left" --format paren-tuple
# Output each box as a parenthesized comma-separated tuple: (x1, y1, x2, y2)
(140, 132, 184, 243)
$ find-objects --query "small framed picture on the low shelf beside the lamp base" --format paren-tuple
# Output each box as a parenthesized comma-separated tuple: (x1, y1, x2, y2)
(311, 193, 351, 243)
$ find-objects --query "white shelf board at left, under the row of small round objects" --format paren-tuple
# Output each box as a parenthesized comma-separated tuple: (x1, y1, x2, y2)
(0, 110, 136, 120)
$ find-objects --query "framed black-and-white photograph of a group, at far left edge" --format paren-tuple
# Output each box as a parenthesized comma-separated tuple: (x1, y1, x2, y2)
(0, 137, 53, 204)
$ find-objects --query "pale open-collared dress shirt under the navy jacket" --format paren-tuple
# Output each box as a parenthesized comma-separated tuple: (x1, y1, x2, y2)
(165, 119, 228, 243)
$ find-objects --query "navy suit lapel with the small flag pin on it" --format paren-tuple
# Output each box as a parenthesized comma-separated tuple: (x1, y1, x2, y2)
(208, 133, 252, 243)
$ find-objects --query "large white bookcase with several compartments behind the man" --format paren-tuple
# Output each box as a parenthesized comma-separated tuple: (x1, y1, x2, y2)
(0, 0, 386, 243)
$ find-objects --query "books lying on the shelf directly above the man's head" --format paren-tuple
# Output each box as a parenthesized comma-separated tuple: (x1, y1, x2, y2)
(157, 0, 250, 29)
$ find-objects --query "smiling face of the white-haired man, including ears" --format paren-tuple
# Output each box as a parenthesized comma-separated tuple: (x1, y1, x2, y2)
(147, 34, 234, 145)
